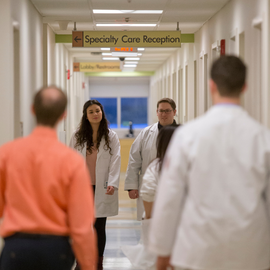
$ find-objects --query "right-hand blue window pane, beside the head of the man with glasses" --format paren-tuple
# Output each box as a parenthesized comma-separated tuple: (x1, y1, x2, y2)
(121, 98, 147, 128)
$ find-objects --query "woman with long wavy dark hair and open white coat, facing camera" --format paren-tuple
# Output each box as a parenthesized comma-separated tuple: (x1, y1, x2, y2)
(70, 100, 120, 269)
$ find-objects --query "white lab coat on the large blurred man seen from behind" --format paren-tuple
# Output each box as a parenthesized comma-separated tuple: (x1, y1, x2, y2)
(149, 105, 270, 270)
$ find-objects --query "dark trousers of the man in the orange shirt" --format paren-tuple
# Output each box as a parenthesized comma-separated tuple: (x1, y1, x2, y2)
(0, 234, 74, 270)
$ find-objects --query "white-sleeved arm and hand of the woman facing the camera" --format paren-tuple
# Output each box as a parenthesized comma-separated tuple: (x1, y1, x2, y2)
(106, 133, 121, 195)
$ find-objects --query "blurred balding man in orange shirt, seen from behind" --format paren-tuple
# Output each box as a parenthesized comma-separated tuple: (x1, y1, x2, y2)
(0, 87, 97, 270)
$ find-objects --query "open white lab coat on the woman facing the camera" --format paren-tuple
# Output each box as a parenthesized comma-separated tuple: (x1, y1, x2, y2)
(70, 130, 121, 217)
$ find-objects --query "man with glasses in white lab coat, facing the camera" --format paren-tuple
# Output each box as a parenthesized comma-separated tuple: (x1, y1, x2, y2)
(125, 98, 176, 220)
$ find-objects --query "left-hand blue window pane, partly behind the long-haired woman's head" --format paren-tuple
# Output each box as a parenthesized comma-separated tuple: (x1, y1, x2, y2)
(91, 97, 117, 128)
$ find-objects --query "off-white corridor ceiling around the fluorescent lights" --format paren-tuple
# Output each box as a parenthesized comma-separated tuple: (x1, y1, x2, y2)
(31, 0, 230, 71)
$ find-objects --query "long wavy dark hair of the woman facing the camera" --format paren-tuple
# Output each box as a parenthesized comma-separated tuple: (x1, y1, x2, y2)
(75, 99, 112, 154)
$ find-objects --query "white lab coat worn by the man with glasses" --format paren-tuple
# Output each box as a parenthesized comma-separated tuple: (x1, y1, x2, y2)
(125, 123, 158, 220)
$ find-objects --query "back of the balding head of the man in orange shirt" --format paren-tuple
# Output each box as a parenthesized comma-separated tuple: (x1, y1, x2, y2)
(33, 86, 67, 127)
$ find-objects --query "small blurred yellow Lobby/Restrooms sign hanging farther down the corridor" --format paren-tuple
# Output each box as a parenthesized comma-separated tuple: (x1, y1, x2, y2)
(73, 62, 121, 72)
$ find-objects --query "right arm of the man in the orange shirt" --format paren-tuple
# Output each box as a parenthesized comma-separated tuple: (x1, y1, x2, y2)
(67, 156, 98, 270)
